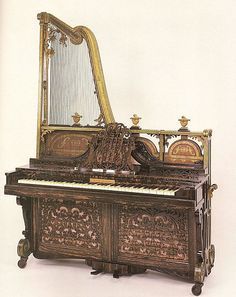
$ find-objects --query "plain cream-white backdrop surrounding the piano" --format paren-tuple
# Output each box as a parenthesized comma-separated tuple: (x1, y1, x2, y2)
(0, 0, 236, 297)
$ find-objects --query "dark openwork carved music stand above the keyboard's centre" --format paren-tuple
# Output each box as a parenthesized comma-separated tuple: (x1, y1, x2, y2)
(84, 123, 135, 170)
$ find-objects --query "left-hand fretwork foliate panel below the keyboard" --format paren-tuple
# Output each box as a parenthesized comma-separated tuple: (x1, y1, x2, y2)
(40, 198, 102, 252)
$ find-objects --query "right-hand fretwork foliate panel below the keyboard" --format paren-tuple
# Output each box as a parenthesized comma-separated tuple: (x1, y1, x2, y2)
(119, 206, 189, 263)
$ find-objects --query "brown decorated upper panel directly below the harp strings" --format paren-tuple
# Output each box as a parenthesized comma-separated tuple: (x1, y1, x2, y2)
(45, 131, 92, 157)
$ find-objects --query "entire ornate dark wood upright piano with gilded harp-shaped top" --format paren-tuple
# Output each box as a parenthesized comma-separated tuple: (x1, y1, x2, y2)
(5, 12, 217, 295)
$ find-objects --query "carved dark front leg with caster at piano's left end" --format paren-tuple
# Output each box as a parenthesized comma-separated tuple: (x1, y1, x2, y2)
(16, 197, 31, 268)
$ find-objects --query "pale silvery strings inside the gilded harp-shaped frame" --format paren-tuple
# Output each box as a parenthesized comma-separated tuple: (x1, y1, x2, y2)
(49, 34, 100, 126)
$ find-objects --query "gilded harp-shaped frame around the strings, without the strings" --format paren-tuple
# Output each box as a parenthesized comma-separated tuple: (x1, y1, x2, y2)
(36, 12, 115, 157)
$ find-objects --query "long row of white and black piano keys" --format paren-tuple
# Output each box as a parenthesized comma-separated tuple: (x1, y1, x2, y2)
(18, 179, 178, 196)
